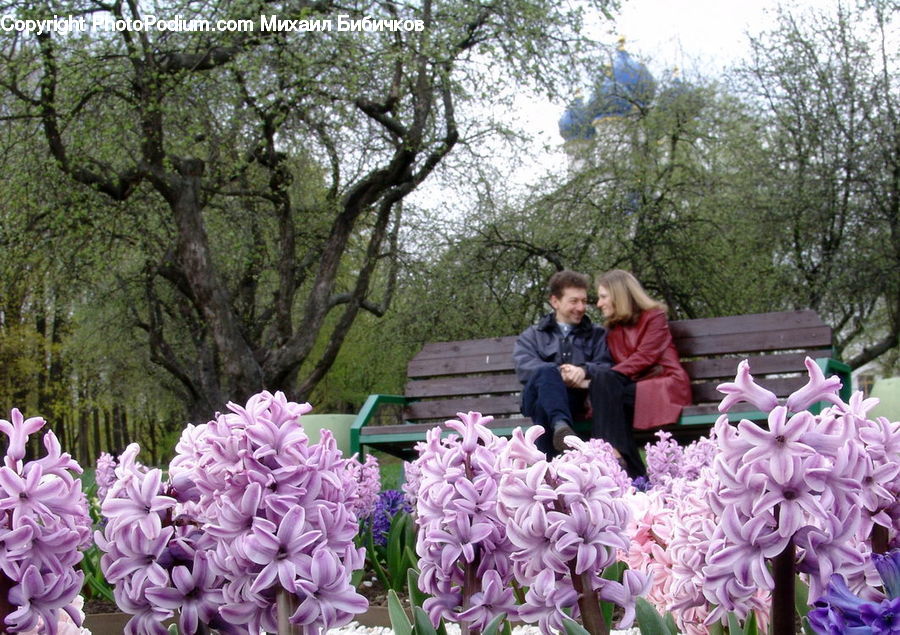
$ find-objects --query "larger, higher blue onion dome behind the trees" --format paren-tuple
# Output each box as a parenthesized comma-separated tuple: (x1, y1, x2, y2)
(588, 41, 656, 120)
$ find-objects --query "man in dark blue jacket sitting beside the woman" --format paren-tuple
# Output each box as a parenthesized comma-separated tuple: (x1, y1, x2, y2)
(513, 270, 612, 458)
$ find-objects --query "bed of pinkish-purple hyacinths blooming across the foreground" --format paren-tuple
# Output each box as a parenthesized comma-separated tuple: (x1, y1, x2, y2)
(0, 362, 900, 635)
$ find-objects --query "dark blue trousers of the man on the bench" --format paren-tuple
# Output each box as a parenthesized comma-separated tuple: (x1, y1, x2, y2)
(522, 365, 587, 459)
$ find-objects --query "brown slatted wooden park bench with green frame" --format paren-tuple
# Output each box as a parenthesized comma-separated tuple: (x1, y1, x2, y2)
(350, 310, 851, 459)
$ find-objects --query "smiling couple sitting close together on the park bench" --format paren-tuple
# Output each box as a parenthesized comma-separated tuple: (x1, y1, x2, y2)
(513, 270, 691, 478)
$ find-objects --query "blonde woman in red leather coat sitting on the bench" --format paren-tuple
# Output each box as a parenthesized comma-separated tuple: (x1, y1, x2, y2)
(590, 269, 691, 478)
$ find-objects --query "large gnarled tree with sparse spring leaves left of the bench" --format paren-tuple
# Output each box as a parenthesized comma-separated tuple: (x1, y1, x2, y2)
(0, 0, 607, 428)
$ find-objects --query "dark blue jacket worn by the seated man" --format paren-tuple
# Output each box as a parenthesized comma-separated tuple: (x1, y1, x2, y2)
(513, 313, 612, 384)
